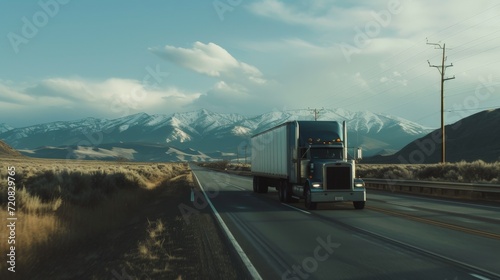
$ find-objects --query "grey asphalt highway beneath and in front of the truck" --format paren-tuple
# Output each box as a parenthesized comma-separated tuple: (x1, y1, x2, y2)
(191, 165, 500, 280)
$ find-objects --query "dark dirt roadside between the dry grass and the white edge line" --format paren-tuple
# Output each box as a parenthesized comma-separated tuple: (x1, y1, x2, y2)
(13, 173, 249, 280)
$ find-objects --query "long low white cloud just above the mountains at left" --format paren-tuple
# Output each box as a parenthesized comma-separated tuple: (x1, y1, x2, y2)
(0, 78, 201, 126)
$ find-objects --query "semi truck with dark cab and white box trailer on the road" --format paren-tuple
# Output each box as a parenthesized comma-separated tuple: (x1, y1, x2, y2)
(251, 121, 366, 210)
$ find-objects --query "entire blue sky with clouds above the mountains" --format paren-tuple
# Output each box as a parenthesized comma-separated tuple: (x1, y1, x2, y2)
(0, 0, 500, 128)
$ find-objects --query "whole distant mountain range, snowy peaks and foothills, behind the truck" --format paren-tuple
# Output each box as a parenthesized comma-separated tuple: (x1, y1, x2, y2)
(0, 109, 432, 161)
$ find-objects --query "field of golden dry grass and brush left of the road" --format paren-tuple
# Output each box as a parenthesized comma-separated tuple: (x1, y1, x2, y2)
(0, 159, 187, 271)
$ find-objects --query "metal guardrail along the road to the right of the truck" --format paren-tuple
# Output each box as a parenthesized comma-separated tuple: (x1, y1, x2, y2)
(363, 178, 500, 200)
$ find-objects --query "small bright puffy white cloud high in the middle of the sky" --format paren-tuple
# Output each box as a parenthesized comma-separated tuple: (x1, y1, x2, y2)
(149, 42, 266, 84)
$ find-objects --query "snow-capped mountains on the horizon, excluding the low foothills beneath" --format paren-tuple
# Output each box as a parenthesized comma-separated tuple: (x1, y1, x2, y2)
(0, 109, 431, 161)
